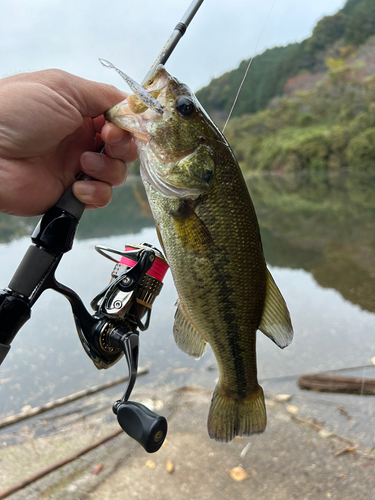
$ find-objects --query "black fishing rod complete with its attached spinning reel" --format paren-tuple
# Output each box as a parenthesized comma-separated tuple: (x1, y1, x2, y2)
(0, 0, 203, 453)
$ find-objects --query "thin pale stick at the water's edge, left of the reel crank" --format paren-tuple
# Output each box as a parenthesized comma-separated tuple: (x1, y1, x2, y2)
(0, 368, 149, 429)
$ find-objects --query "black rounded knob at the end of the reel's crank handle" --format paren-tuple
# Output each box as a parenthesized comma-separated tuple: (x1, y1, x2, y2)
(113, 401, 168, 453)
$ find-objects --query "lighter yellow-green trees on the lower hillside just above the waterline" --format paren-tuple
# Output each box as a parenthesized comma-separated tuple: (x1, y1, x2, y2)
(225, 56, 375, 172)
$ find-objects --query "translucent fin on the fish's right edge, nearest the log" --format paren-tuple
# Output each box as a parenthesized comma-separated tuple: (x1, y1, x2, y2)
(259, 269, 293, 349)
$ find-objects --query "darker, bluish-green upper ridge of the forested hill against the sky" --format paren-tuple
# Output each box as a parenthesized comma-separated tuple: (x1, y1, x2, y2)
(197, 0, 375, 121)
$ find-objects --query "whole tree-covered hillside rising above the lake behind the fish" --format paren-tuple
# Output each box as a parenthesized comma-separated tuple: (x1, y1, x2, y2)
(197, 0, 375, 172)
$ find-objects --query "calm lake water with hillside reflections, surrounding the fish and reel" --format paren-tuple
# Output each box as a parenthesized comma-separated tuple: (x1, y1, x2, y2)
(0, 172, 375, 445)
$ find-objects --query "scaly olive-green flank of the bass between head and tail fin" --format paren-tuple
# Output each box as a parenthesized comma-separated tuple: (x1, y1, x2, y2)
(144, 155, 266, 396)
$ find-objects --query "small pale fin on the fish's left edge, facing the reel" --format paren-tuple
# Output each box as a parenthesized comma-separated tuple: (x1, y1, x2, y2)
(173, 300, 207, 359)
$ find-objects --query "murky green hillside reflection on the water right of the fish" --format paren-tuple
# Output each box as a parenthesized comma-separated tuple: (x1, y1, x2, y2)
(248, 172, 375, 312)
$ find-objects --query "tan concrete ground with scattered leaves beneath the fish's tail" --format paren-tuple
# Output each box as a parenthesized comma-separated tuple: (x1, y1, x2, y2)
(0, 387, 375, 500)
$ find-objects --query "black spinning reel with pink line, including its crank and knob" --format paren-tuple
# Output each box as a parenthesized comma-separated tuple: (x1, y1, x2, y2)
(58, 243, 168, 453)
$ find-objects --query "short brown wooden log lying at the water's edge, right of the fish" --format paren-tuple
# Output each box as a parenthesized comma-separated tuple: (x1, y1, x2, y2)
(298, 373, 375, 395)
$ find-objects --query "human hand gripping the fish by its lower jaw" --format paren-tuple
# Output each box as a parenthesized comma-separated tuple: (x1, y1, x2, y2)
(0, 69, 137, 216)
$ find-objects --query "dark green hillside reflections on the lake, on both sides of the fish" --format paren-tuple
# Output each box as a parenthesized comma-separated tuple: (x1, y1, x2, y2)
(0, 171, 375, 312)
